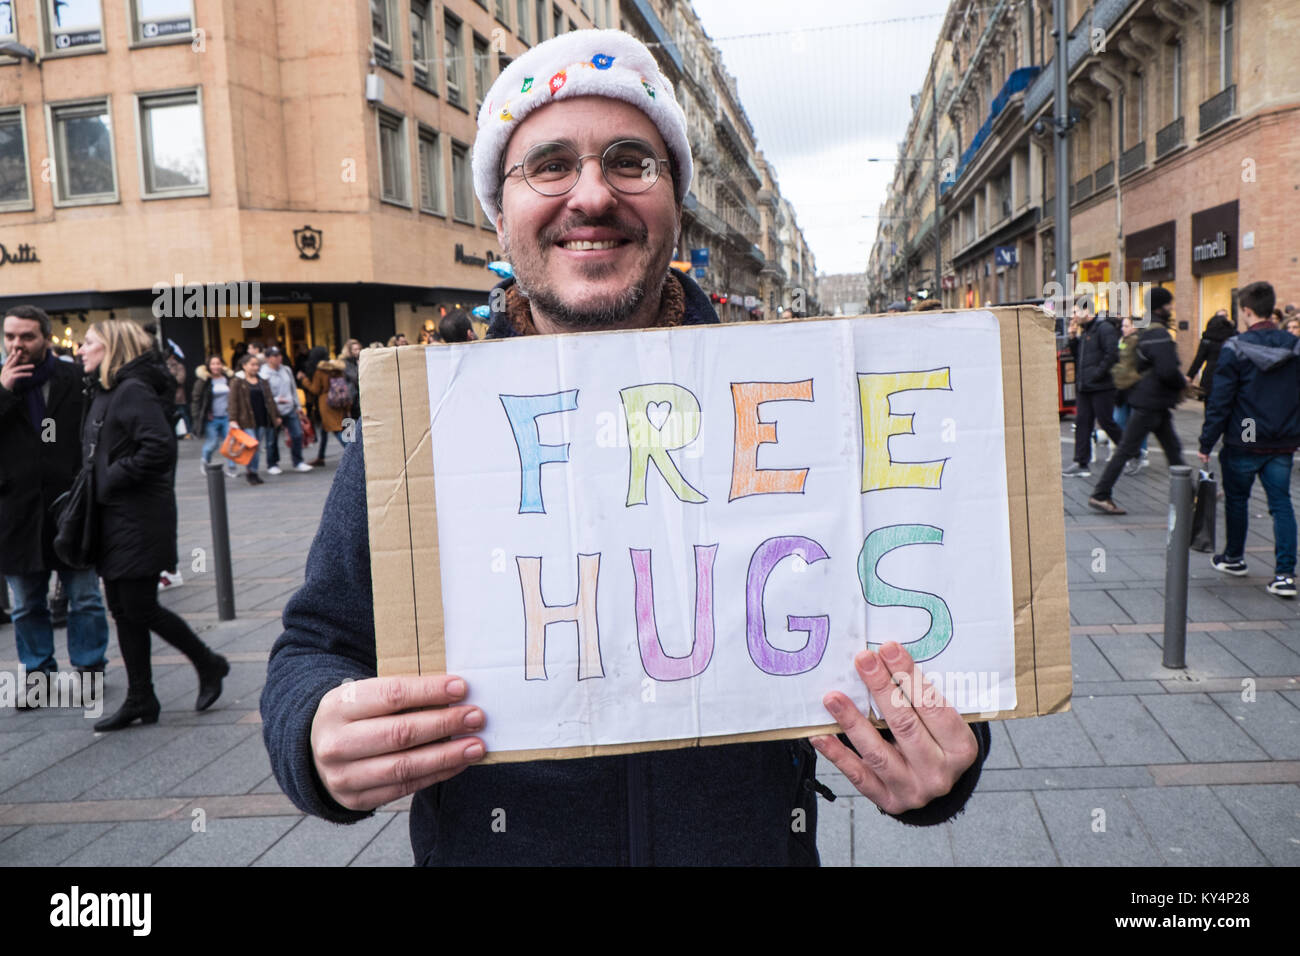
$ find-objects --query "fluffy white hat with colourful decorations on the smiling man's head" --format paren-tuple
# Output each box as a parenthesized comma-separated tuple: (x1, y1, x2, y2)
(473, 30, 694, 222)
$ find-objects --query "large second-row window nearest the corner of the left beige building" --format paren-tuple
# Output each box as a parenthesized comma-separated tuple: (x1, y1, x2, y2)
(138, 90, 208, 198)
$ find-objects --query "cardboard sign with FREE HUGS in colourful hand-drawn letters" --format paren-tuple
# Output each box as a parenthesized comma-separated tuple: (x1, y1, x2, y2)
(361, 308, 1070, 761)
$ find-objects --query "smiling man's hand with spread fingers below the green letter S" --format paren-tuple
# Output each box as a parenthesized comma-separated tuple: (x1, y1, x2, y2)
(813, 641, 979, 813)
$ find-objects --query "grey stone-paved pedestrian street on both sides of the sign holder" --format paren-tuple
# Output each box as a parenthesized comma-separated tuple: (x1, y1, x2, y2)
(0, 406, 1300, 866)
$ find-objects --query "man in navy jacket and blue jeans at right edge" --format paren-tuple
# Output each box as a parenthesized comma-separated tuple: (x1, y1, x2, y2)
(1200, 282, 1300, 597)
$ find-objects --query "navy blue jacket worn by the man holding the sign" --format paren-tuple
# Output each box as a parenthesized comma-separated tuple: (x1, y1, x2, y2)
(261, 270, 989, 865)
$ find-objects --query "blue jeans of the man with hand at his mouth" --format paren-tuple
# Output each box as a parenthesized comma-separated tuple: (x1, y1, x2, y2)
(7, 568, 110, 671)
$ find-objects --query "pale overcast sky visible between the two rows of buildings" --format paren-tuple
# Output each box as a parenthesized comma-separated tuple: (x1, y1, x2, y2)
(693, 0, 948, 273)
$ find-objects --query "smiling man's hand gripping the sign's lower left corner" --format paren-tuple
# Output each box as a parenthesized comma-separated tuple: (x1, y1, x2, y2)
(312, 674, 484, 810)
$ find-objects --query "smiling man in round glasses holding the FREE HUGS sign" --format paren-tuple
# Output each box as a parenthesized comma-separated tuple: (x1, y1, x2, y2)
(261, 30, 989, 865)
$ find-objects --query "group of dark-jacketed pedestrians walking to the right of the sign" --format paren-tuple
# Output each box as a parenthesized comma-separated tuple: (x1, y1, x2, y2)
(1062, 282, 1300, 598)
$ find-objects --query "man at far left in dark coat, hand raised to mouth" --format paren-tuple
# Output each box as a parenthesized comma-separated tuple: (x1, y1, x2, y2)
(0, 306, 108, 697)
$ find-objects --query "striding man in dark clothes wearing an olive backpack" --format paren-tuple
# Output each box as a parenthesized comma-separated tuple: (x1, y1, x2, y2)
(1088, 286, 1187, 515)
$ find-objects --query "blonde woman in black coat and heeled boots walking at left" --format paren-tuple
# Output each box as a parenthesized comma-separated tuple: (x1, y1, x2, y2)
(81, 321, 230, 731)
